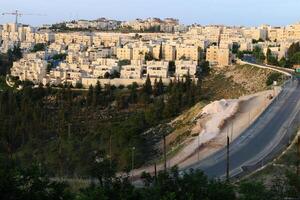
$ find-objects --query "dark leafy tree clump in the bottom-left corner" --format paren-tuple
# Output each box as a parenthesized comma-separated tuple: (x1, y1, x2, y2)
(0, 161, 74, 200)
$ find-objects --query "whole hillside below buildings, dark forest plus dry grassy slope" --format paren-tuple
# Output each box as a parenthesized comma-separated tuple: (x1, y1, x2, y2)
(0, 63, 284, 177)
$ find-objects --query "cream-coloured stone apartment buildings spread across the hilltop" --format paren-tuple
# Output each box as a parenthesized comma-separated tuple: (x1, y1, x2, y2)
(0, 18, 300, 88)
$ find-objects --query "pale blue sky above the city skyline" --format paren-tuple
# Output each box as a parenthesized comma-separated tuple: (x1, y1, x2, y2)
(0, 0, 300, 26)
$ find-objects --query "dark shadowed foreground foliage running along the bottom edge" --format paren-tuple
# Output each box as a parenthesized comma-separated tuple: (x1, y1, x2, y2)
(0, 158, 300, 200)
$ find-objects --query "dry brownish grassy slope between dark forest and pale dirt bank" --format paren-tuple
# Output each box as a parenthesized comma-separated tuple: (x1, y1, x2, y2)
(148, 65, 282, 164)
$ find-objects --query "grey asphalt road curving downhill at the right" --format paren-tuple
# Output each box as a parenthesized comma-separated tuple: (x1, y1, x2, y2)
(185, 75, 300, 178)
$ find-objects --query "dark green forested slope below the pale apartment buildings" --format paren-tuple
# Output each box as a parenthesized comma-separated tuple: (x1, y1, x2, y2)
(0, 73, 199, 176)
